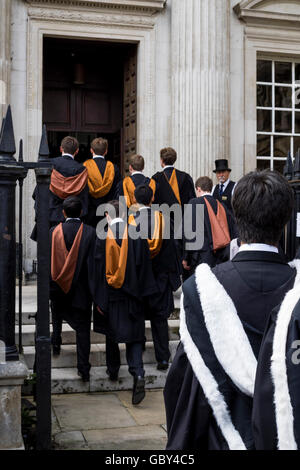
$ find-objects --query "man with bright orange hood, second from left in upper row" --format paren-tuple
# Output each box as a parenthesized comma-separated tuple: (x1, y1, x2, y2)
(84, 137, 121, 228)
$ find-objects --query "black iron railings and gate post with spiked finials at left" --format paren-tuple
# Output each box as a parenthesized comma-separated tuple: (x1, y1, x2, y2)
(0, 106, 52, 450)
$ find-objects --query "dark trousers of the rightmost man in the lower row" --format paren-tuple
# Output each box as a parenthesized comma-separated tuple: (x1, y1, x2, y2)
(150, 313, 171, 362)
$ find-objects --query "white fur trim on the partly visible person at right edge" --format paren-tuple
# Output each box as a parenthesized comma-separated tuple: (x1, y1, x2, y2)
(271, 260, 300, 450)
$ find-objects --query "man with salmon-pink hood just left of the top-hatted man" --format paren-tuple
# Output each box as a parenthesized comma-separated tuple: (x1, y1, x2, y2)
(182, 176, 234, 275)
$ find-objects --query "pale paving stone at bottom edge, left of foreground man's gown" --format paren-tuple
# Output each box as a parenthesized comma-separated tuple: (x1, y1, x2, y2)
(83, 425, 167, 451)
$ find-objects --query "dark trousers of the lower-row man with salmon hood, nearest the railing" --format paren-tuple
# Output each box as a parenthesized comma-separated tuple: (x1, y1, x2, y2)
(51, 300, 91, 374)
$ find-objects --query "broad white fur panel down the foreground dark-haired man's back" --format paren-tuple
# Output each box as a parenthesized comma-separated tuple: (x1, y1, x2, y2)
(195, 264, 257, 397)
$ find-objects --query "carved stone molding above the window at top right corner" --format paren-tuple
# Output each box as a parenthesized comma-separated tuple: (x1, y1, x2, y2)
(233, 0, 300, 28)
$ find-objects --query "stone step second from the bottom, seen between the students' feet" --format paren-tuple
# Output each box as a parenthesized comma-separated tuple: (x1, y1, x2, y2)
(23, 340, 179, 369)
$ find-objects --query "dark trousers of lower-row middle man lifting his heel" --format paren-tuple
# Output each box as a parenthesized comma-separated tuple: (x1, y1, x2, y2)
(106, 336, 145, 377)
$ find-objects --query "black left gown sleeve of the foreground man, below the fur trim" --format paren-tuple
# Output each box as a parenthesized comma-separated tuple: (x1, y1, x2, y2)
(164, 343, 211, 450)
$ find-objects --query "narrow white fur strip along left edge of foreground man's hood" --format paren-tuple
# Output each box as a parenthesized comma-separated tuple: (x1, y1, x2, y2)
(180, 294, 246, 450)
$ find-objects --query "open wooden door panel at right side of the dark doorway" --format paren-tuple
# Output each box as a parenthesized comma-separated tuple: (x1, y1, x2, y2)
(122, 46, 137, 173)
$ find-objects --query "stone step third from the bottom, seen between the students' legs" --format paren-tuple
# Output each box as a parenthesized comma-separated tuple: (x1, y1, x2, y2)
(16, 320, 179, 346)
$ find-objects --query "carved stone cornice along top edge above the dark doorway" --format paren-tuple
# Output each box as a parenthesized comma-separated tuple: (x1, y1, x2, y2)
(24, 0, 167, 14)
